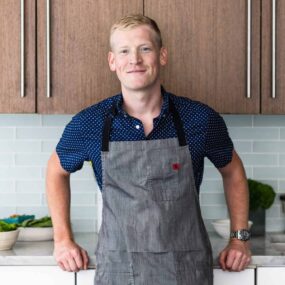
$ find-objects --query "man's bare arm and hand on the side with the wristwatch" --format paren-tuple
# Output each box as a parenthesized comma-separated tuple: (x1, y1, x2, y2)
(216, 151, 251, 271)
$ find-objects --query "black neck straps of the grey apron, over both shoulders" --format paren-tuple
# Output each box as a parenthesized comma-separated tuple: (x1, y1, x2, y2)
(102, 98, 187, 151)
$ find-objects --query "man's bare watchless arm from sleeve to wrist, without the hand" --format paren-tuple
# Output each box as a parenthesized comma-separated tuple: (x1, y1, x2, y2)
(46, 152, 73, 241)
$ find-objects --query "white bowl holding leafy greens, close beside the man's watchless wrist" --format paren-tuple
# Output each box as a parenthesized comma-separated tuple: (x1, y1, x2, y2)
(18, 227, 53, 241)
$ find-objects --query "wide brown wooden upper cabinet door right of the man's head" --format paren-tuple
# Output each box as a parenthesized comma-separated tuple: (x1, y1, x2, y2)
(144, 0, 260, 113)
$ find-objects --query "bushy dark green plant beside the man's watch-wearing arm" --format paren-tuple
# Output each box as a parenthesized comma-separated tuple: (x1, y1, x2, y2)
(247, 179, 276, 212)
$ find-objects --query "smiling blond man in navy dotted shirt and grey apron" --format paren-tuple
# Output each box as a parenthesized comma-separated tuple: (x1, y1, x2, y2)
(47, 15, 250, 285)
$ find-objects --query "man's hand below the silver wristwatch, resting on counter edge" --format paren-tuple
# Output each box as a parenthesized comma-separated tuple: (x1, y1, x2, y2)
(219, 239, 251, 271)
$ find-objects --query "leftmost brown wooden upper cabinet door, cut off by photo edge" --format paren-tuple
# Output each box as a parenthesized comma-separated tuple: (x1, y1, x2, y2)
(0, 0, 36, 113)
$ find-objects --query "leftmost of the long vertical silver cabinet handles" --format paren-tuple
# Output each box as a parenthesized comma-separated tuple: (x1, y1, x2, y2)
(20, 0, 25, 98)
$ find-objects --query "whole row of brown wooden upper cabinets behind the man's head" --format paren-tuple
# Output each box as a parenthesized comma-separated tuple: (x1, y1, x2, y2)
(0, 0, 285, 114)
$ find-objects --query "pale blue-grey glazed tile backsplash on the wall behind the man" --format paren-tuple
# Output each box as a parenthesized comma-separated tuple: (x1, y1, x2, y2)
(0, 114, 285, 232)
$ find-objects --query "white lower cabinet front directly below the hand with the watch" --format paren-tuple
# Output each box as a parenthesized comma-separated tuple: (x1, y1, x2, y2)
(214, 269, 255, 285)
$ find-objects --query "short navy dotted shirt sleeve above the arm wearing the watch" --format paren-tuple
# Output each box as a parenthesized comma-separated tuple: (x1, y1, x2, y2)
(206, 110, 233, 168)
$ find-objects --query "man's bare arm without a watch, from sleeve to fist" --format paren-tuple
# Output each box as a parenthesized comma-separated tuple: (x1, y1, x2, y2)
(46, 152, 88, 271)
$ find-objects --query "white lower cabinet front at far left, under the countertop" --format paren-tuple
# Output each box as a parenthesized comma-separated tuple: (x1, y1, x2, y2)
(0, 266, 75, 285)
